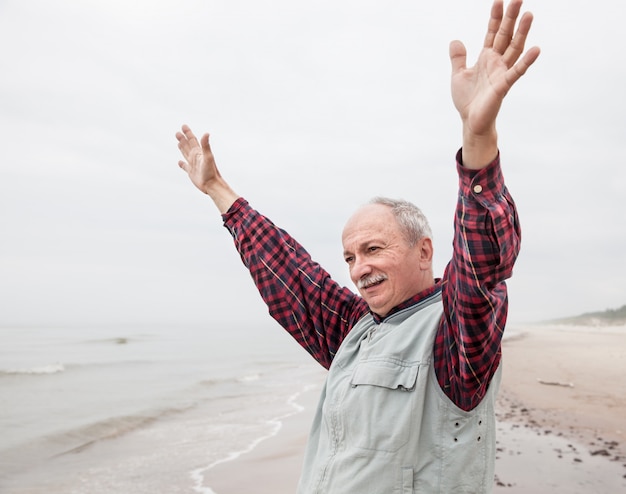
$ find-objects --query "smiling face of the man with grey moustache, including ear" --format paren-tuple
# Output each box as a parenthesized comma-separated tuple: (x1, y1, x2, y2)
(342, 204, 433, 317)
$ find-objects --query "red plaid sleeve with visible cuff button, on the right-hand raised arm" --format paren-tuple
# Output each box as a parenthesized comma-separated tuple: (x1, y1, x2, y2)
(434, 151, 521, 410)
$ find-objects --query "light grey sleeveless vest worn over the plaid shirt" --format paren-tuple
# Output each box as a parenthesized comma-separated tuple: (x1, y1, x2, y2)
(298, 292, 501, 494)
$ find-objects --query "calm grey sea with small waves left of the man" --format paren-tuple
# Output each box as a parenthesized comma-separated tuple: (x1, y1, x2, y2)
(0, 320, 324, 494)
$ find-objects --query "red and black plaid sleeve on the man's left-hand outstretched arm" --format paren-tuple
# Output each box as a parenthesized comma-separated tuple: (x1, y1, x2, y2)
(224, 198, 368, 368)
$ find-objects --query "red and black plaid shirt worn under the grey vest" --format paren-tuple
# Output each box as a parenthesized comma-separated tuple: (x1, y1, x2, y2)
(224, 151, 520, 410)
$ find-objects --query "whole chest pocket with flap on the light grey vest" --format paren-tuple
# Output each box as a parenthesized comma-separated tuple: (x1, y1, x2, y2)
(344, 357, 419, 452)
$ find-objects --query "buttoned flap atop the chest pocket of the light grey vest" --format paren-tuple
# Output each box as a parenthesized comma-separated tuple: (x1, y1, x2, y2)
(350, 358, 419, 391)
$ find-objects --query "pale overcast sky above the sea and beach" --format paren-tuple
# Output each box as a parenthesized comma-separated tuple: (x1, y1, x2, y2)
(0, 0, 626, 326)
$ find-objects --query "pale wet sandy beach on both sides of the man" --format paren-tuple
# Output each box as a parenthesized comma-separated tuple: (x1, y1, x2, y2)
(200, 326, 626, 494)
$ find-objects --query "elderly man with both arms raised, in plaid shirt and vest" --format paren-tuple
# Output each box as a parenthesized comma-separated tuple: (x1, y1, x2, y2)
(176, 0, 539, 494)
